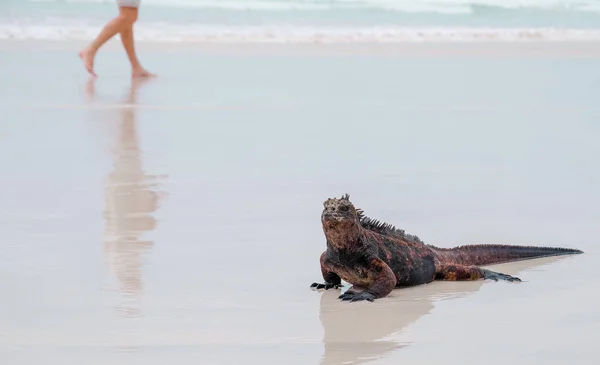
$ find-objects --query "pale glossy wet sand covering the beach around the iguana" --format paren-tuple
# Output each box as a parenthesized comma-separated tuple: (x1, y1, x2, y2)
(0, 43, 600, 365)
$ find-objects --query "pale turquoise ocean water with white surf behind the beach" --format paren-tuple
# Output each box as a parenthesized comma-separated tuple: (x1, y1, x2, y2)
(0, 0, 600, 42)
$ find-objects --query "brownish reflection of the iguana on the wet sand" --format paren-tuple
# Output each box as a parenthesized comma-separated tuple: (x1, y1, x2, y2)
(319, 256, 566, 365)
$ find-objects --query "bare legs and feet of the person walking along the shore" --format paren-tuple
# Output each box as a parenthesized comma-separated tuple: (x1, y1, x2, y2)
(79, 6, 153, 77)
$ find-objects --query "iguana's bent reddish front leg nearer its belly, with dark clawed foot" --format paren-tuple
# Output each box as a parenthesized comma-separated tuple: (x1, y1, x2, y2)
(339, 257, 397, 302)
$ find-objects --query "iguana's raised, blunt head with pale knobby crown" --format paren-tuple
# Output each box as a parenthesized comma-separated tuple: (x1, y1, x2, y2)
(321, 194, 360, 248)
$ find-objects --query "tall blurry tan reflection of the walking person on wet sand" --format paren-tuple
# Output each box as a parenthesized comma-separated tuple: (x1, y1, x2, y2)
(88, 79, 165, 316)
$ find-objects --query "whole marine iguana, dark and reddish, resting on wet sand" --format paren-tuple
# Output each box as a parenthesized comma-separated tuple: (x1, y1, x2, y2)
(311, 194, 583, 302)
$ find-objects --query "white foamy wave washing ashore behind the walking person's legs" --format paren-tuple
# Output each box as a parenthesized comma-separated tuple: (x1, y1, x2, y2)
(0, 22, 600, 43)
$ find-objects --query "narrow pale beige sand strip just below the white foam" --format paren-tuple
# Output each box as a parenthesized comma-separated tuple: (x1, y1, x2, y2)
(0, 37, 600, 58)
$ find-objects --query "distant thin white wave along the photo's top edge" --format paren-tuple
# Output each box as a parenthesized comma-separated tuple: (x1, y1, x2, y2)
(27, 0, 600, 14)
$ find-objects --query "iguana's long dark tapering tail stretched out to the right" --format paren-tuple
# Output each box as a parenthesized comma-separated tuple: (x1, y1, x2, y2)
(435, 245, 583, 266)
